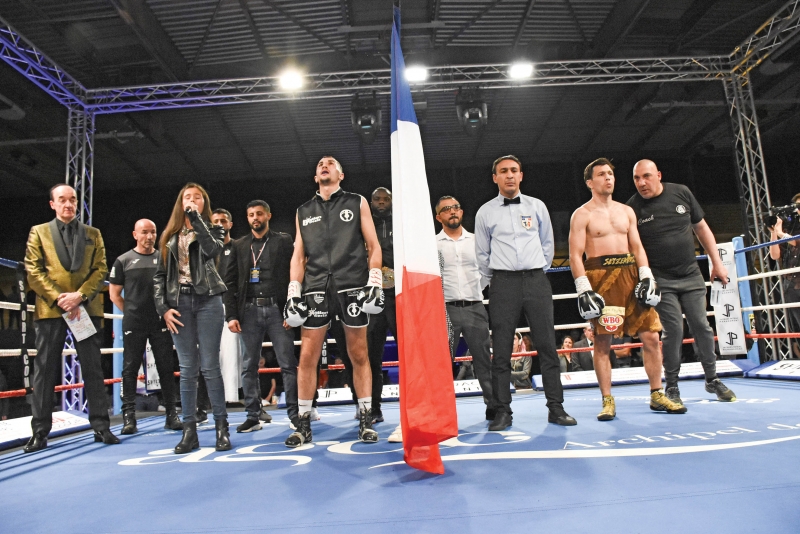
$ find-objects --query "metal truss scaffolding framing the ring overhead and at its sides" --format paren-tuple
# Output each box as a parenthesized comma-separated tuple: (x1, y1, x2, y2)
(0, 0, 800, 359)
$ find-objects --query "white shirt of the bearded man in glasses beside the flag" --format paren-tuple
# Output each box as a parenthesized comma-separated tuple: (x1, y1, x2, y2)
(436, 228, 483, 302)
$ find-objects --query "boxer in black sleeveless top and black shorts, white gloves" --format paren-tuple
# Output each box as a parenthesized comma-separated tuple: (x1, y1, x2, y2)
(285, 156, 383, 448)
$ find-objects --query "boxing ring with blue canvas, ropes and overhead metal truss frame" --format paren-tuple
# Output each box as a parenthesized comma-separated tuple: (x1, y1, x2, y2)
(0, 1, 800, 533)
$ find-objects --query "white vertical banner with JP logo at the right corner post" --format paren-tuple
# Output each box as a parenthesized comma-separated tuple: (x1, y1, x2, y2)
(708, 243, 747, 355)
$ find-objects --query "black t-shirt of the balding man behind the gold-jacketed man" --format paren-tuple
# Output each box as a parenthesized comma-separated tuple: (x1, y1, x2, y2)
(108, 250, 166, 332)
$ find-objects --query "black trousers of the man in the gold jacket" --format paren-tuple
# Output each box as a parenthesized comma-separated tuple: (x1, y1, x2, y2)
(31, 317, 109, 436)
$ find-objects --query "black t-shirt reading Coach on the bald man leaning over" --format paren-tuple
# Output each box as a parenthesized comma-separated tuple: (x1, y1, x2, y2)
(627, 182, 705, 279)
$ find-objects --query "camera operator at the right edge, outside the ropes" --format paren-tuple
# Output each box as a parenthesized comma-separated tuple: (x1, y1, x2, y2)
(768, 193, 800, 358)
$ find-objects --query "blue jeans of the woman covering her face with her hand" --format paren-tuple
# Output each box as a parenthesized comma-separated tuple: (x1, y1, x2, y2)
(172, 293, 228, 423)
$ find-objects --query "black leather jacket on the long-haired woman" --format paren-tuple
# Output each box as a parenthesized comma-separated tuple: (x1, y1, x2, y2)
(153, 211, 227, 317)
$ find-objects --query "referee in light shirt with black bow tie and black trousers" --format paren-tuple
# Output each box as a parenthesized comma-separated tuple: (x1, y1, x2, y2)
(475, 155, 577, 430)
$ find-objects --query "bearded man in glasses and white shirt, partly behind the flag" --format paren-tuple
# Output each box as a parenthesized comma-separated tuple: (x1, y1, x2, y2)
(436, 196, 497, 421)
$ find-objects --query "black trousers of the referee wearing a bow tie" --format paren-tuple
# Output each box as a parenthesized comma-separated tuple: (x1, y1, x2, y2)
(489, 269, 564, 414)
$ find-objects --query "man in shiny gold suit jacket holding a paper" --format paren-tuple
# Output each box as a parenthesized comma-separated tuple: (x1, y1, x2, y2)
(24, 184, 119, 452)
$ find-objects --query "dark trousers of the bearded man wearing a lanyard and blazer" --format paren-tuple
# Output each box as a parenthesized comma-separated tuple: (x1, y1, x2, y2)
(240, 303, 297, 421)
